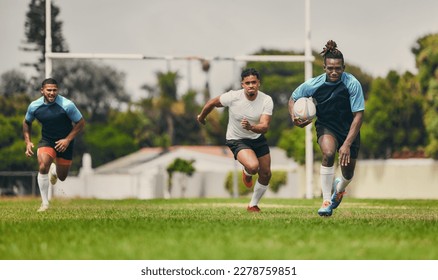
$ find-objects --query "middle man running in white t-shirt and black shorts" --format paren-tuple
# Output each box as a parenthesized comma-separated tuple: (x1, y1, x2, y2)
(197, 68, 274, 212)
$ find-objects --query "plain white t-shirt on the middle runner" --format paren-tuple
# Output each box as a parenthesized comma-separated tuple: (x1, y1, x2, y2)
(219, 89, 274, 140)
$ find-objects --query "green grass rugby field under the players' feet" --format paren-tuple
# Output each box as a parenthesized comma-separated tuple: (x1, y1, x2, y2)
(0, 197, 438, 260)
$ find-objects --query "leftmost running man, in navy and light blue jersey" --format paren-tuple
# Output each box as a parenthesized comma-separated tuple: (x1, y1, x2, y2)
(23, 78, 85, 212)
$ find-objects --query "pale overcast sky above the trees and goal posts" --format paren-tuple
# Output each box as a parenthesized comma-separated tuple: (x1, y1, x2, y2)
(0, 0, 438, 98)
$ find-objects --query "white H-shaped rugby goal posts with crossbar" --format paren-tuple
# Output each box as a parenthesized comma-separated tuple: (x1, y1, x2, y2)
(45, 0, 315, 199)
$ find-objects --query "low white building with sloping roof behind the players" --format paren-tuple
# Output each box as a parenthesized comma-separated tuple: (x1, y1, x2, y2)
(53, 146, 300, 199)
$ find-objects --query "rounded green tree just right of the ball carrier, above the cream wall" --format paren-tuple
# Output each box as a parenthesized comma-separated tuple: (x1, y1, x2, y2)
(361, 71, 426, 158)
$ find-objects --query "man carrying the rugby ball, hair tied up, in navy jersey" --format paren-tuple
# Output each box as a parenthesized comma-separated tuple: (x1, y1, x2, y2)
(289, 40, 365, 216)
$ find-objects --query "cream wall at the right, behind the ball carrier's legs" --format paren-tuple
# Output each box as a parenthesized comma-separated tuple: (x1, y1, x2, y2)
(298, 159, 438, 199)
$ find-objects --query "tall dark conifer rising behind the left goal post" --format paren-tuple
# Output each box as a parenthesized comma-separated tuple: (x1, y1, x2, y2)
(24, 0, 68, 72)
